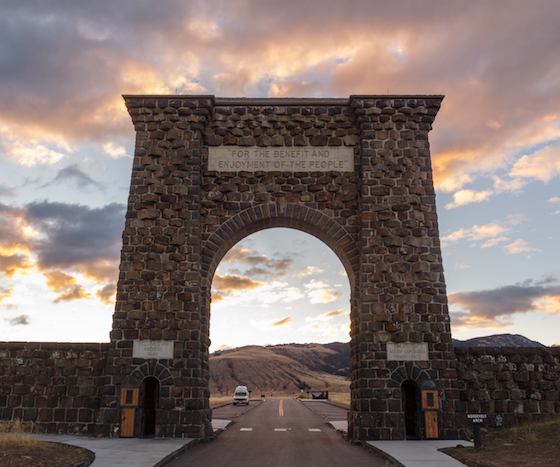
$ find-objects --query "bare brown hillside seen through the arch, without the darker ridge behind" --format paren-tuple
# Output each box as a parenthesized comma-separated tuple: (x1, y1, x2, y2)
(210, 344, 350, 396)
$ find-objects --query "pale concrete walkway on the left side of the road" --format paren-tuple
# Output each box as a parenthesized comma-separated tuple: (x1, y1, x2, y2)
(33, 419, 231, 467)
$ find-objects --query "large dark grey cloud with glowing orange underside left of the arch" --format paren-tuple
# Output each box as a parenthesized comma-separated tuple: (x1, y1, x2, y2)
(0, 201, 124, 303)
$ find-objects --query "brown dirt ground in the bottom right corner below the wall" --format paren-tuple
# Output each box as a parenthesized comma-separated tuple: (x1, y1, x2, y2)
(442, 418, 560, 467)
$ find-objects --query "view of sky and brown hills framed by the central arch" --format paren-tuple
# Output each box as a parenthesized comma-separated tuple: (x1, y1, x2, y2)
(209, 226, 351, 412)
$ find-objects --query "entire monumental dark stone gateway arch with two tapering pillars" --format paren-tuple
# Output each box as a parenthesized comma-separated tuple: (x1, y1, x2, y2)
(103, 95, 459, 440)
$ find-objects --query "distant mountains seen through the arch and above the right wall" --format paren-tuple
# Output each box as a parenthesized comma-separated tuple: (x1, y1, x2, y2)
(210, 334, 545, 395)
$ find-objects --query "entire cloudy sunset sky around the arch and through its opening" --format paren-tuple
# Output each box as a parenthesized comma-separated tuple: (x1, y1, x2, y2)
(0, 0, 560, 349)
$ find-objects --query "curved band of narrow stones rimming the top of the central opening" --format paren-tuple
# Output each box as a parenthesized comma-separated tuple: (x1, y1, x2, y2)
(201, 203, 359, 290)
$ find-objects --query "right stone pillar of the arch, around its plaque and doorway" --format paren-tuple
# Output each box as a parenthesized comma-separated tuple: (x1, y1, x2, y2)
(349, 96, 459, 439)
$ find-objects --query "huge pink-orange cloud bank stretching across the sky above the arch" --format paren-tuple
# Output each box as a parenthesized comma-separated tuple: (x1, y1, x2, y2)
(0, 0, 560, 191)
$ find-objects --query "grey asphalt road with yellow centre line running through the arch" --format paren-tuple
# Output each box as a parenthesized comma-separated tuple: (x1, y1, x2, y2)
(169, 399, 391, 467)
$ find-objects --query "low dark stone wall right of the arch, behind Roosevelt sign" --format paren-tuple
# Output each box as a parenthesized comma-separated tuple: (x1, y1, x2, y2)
(455, 347, 560, 426)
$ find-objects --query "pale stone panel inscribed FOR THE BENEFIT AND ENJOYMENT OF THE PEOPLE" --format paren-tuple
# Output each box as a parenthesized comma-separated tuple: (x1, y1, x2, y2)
(208, 146, 354, 172)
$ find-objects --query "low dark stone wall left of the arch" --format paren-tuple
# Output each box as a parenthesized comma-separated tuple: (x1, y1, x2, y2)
(0, 342, 110, 434)
